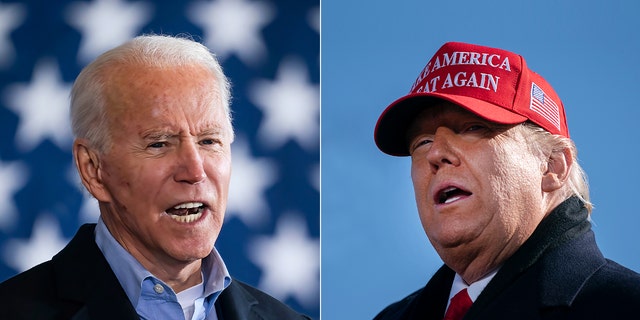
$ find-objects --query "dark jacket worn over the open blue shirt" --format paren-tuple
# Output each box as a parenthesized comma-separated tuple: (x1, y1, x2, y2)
(0, 224, 307, 320)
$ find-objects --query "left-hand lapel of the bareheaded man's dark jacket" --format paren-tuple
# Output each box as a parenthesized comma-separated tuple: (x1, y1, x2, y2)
(52, 225, 139, 320)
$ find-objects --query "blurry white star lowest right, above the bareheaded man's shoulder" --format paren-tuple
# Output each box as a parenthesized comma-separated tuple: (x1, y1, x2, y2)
(249, 213, 320, 305)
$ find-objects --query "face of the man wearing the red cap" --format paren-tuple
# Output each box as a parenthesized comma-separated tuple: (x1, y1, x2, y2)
(409, 104, 547, 281)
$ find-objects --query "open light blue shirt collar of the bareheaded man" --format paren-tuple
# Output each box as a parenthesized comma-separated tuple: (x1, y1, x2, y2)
(96, 218, 231, 306)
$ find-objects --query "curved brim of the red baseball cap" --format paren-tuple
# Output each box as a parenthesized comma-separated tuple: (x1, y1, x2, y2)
(374, 92, 527, 156)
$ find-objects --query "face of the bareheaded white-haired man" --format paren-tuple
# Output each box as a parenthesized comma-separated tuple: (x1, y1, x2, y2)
(82, 65, 232, 270)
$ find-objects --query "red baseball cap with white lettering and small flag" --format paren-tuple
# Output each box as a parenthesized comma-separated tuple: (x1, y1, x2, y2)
(374, 42, 569, 156)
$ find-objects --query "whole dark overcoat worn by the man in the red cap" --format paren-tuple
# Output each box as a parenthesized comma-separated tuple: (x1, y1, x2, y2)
(376, 198, 640, 320)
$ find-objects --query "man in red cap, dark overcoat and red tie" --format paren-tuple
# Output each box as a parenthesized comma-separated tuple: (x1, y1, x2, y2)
(374, 42, 640, 320)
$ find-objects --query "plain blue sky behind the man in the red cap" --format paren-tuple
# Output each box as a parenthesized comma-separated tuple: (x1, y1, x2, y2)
(321, 0, 640, 320)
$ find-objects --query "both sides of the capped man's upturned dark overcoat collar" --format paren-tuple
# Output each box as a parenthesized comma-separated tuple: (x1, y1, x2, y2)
(404, 197, 606, 319)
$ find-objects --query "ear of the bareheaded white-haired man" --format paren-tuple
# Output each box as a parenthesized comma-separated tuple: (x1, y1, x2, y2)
(73, 139, 111, 202)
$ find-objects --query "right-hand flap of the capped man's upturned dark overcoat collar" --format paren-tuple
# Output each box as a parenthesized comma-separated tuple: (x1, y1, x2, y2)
(467, 197, 606, 319)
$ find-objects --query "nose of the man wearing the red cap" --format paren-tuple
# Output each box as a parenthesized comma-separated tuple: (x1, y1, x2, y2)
(427, 127, 460, 173)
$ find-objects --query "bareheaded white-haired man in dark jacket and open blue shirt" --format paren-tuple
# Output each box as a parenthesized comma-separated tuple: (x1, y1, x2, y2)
(0, 36, 306, 320)
